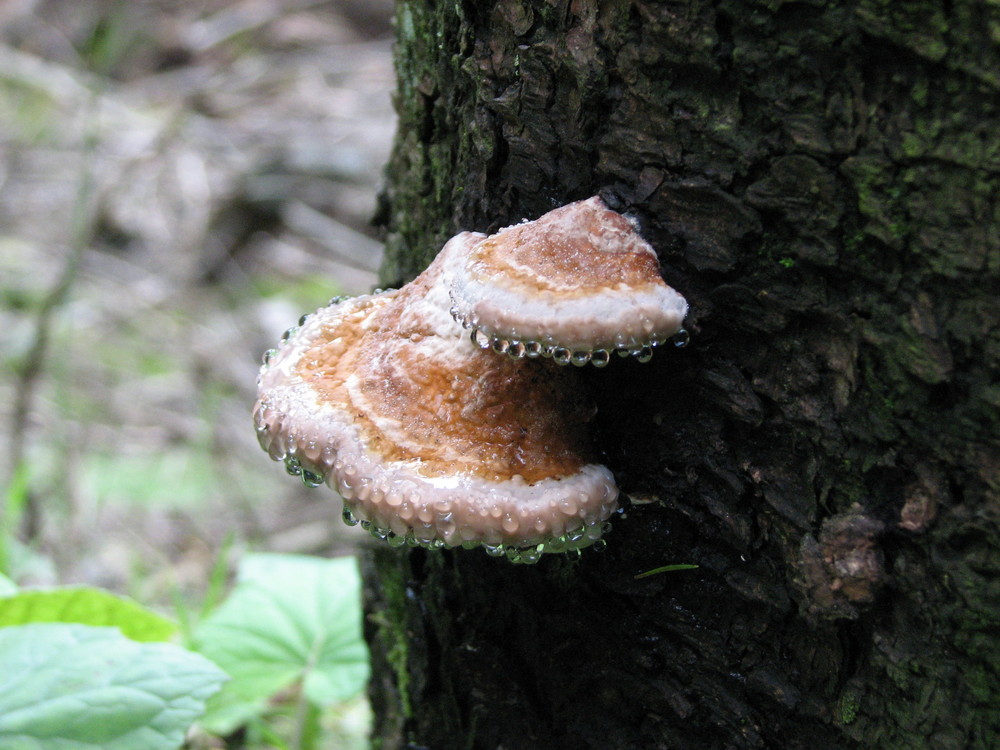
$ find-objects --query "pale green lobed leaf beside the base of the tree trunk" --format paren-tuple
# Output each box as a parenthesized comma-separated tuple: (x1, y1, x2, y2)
(194, 554, 368, 732)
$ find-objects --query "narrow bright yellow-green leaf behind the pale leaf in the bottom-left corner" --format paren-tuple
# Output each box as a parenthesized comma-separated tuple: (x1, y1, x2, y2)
(0, 586, 177, 641)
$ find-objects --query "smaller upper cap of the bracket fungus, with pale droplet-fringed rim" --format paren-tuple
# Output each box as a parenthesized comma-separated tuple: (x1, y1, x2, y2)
(451, 196, 688, 365)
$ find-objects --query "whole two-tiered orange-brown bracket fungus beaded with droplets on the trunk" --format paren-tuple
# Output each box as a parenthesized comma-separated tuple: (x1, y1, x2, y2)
(254, 198, 687, 562)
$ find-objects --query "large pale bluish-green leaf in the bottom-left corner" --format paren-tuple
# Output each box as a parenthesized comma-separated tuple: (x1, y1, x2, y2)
(0, 623, 226, 750)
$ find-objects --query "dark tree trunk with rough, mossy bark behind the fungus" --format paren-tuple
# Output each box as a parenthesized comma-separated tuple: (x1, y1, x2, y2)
(368, 0, 1000, 750)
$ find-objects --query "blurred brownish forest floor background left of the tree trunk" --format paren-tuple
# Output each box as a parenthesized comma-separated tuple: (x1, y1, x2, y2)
(0, 0, 395, 606)
